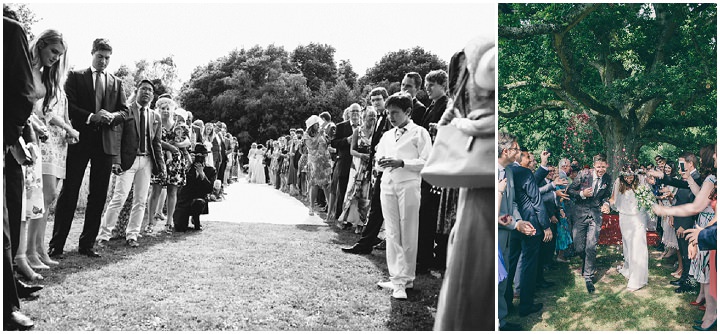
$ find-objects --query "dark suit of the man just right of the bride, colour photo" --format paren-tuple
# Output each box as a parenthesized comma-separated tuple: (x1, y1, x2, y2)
(661, 169, 702, 282)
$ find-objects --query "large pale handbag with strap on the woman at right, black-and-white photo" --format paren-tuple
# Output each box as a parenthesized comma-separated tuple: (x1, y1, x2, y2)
(420, 58, 496, 188)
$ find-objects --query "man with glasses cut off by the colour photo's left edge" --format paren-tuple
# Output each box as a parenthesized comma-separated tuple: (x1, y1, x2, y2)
(497, 132, 535, 331)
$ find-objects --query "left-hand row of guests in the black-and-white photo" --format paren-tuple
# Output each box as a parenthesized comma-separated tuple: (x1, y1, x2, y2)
(3, 10, 241, 329)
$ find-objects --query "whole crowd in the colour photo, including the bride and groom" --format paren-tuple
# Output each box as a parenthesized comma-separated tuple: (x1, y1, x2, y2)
(497, 132, 717, 330)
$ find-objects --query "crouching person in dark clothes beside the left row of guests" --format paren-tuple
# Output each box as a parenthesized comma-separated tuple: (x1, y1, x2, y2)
(173, 144, 216, 232)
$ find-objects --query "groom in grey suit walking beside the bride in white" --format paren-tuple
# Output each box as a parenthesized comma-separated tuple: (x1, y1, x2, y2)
(568, 154, 612, 294)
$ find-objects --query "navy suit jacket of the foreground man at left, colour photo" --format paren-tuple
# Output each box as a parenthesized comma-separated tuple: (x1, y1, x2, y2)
(506, 164, 550, 235)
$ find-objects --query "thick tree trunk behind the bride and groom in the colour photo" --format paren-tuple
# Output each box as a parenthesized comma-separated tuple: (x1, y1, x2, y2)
(596, 116, 642, 178)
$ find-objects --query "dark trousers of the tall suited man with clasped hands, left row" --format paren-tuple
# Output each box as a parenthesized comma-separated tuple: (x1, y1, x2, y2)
(50, 134, 112, 252)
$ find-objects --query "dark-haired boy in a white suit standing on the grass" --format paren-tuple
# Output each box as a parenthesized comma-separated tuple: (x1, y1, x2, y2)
(376, 93, 432, 299)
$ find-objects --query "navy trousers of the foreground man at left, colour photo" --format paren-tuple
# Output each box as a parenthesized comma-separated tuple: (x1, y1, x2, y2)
(505, 231, 543, 312)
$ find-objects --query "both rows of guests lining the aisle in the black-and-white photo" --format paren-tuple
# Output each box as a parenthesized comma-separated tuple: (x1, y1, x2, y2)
(3, 9, 495, 330)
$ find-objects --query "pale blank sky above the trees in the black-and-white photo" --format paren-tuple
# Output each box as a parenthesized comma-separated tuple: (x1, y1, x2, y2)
(22, 1, 497, 88)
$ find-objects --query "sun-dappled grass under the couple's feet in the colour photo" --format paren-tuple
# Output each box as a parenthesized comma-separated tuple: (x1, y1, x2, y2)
(507, 245, 703, 331)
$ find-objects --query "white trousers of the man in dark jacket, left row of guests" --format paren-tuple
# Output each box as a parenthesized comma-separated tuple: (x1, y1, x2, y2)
(97, 156, 152, 240)
